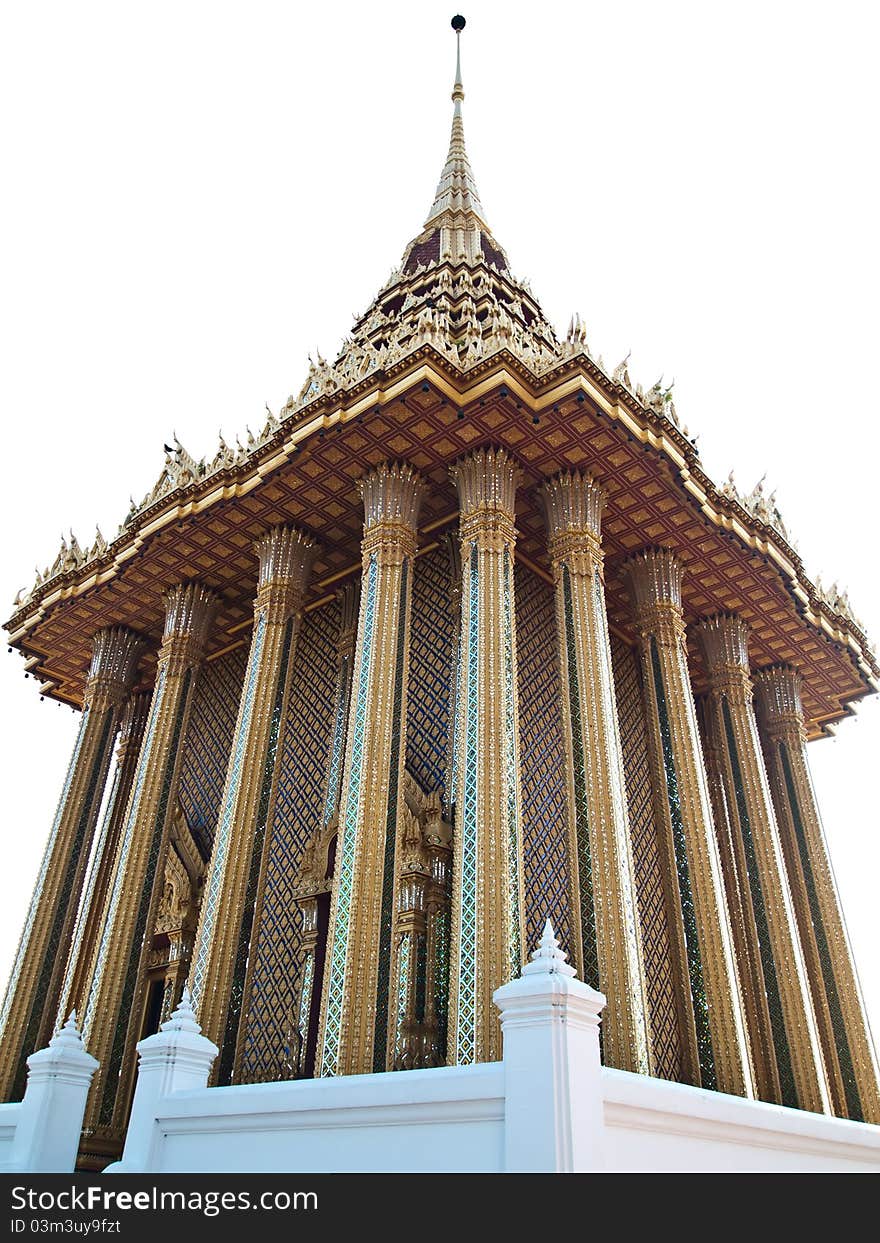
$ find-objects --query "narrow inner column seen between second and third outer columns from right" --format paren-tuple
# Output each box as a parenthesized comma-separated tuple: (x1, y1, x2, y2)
(696, 695, 781, 1101)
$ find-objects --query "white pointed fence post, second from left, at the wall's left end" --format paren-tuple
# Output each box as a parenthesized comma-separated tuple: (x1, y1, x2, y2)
(104, 988, 219, 1173)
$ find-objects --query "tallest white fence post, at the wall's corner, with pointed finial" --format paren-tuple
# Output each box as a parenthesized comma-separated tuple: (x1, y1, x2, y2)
(493, 920, 605, 1172)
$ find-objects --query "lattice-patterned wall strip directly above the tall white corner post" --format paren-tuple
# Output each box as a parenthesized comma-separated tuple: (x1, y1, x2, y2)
(515, 563, 571, 951)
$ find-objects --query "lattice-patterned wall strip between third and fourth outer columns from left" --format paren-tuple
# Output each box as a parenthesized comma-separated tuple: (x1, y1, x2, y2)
(241, 603, 339, 1083)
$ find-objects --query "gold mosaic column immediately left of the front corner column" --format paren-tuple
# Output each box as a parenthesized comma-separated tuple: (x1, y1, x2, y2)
(318, 464, 423, 1075)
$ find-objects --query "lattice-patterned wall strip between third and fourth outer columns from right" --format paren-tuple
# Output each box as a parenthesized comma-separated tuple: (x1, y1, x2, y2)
(612, 635, 682, 1079)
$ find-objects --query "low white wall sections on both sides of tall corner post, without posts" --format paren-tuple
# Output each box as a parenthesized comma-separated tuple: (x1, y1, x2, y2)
(111, 1063, 880, 1173)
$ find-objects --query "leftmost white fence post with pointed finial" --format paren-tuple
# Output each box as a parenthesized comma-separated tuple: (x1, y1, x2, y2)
(6, 1014, 98, 1173)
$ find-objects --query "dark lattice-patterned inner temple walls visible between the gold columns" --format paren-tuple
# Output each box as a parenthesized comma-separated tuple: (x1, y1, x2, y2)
(162, 546, 750, 1081)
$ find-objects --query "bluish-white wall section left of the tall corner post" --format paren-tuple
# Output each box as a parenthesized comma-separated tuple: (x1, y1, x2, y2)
(111, 1063, 505, 1173)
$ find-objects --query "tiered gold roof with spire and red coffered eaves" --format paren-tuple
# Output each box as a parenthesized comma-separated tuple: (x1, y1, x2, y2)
(6, 21, 880, 733)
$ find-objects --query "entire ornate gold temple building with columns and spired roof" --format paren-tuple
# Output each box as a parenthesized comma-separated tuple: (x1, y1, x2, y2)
(0, 19, 880, 1168)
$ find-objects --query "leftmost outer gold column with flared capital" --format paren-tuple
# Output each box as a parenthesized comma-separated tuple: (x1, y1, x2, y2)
(0, 626, 144, 1100)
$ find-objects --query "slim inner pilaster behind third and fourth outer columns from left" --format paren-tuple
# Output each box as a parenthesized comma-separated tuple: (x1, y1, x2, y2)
(296, 582, 360, 1079)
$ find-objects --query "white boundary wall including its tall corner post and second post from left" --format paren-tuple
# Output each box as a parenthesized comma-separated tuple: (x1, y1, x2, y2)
(109, 926, 880, 1173)
